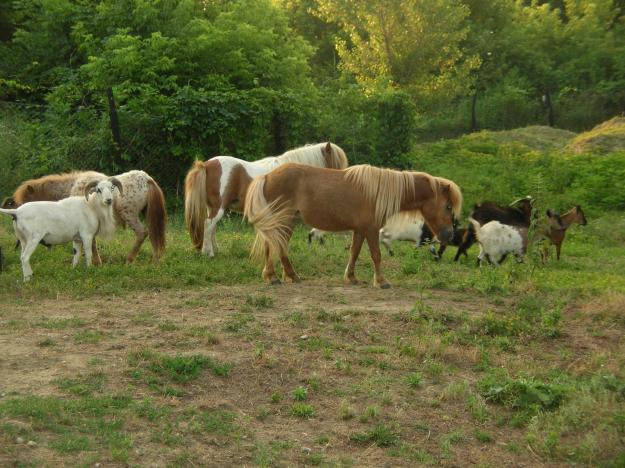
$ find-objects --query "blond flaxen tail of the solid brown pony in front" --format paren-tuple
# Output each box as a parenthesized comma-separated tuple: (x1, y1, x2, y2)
(243, 176, 293, 260)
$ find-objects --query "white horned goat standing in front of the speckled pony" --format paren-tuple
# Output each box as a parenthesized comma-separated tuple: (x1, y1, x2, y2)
(0, 177, 122, 281)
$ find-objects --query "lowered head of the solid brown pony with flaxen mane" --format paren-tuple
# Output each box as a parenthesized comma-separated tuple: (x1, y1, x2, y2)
(420, 177, 462, 243)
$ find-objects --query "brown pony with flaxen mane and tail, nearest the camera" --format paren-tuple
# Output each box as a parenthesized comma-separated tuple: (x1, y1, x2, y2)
(244, 164, 462, 288)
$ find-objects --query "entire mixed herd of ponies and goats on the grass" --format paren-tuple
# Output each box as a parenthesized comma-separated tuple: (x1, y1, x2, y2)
(0, 142, 586, 288)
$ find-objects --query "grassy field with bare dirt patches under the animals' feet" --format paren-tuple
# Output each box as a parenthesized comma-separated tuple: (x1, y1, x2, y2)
(0, 212, 625, 466)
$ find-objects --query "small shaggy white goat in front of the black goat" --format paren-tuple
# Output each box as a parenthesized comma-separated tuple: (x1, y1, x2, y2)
(469, 218, 527, 265)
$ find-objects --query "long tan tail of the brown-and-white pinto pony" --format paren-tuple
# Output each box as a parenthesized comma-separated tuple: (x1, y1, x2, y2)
(184, 161, 208, 250)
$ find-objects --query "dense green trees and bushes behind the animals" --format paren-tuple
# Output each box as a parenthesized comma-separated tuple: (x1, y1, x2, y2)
(0, 0, 625, 201)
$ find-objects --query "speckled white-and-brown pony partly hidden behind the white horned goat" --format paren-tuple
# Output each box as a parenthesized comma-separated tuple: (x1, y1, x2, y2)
(4, 171, 167, 264)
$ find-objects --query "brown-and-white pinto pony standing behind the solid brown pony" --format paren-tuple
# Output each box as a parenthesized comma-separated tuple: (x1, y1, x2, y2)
(184, 142, 347, 257)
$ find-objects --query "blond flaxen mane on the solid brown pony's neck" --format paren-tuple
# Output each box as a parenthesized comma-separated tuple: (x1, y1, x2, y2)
(345, 164, 422, 226)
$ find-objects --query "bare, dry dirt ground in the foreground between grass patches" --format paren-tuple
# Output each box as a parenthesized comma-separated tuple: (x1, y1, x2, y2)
(0, 281, 580, 466)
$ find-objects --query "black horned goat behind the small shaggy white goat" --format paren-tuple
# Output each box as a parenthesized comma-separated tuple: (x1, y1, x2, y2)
(454, 196, 533, 261)
